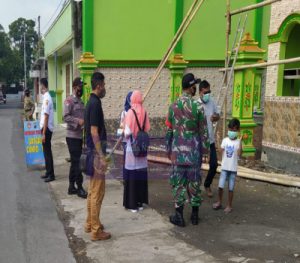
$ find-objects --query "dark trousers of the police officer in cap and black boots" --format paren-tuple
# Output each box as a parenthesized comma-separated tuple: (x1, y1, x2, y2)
(66, 137, 83, 187)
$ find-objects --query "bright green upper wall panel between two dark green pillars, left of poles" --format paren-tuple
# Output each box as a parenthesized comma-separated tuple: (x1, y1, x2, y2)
(94, 0, 175, 60)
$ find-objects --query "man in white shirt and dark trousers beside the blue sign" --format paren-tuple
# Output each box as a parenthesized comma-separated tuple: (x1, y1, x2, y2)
(40, 78, 55, 183)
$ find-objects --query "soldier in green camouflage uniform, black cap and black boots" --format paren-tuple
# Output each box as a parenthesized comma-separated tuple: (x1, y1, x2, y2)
(166, 74, 209, 227)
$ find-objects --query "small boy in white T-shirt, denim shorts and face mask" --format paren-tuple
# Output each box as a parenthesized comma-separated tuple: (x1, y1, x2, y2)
(213, 118, 242, 213)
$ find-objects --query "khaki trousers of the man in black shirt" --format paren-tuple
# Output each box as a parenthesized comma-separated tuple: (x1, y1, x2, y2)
(85, 176, 105, 236)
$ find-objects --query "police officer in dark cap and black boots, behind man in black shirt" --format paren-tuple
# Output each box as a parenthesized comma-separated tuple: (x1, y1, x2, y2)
(64, 78, 87, 198)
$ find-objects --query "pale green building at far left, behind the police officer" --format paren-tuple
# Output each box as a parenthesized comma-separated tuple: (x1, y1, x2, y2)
(45, 1, 81, 123)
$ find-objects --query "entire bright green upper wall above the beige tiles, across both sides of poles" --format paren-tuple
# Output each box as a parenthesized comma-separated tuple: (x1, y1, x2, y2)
(91, 0, 270, 61)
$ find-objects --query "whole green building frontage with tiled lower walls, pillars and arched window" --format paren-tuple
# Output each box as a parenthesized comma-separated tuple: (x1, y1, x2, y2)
(45, 0, 300, 173)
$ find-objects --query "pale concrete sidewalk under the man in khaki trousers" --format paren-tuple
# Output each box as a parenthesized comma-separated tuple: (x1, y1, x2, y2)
(49, 127, 217, 263)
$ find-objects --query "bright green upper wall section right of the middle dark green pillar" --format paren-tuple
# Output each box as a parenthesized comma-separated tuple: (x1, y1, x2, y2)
(183, 0, 266, 60)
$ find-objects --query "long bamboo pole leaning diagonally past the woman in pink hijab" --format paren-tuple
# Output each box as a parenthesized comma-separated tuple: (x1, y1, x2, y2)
(106, 0, 204, 160)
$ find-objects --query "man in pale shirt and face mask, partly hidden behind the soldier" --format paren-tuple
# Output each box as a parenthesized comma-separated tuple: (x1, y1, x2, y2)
(198, 80, 220, 197)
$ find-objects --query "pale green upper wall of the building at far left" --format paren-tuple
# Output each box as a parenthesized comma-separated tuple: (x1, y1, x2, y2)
(45, 2, 72, 57)
